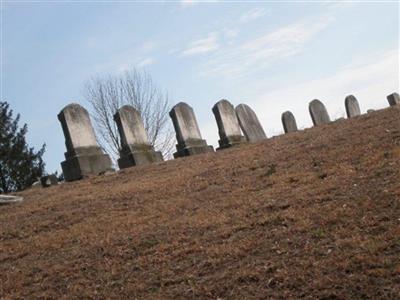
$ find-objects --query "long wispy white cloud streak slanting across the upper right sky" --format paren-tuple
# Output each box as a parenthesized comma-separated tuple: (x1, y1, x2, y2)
(202, 17, 334, 77)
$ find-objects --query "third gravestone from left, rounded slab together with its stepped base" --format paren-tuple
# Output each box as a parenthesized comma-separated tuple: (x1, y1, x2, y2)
(169, 102, 214, 158)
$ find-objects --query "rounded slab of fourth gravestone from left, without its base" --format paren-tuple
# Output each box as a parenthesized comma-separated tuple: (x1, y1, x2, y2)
(212, 99, 242, 139)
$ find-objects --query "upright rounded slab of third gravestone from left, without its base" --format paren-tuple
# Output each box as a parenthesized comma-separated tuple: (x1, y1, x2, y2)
(169, 102, 202, 143)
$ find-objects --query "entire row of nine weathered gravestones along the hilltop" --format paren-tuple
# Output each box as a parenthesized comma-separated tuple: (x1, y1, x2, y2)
(58, 93, 400, 181)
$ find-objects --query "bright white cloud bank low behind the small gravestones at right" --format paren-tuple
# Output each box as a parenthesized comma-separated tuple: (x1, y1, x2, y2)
(200, 49, 400, 146)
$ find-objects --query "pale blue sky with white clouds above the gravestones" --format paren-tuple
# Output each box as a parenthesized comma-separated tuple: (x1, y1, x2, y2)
(0, 0, 400, 173)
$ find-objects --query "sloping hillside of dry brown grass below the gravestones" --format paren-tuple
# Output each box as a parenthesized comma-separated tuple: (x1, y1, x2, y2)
(0, 106, 400, 299)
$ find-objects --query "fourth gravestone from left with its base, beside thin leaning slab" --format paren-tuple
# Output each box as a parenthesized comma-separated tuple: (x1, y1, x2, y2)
(212, 99, 246, 150)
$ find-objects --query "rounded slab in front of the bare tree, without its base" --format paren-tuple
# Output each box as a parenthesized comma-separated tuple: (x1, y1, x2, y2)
(114, 105, 149, 146)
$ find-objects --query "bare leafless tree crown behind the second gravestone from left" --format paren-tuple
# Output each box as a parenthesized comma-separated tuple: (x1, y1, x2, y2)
(83, 69, 174, 161)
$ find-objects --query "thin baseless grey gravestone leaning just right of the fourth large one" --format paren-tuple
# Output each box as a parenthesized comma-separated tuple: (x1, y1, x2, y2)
(235, 104, 267, 143)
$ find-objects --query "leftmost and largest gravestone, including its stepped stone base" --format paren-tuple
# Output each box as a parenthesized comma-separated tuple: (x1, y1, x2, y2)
(58, 103, 112, 181)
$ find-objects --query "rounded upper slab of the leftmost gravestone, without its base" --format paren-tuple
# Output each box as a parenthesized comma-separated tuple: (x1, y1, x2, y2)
(58, 103, 97, 152)
